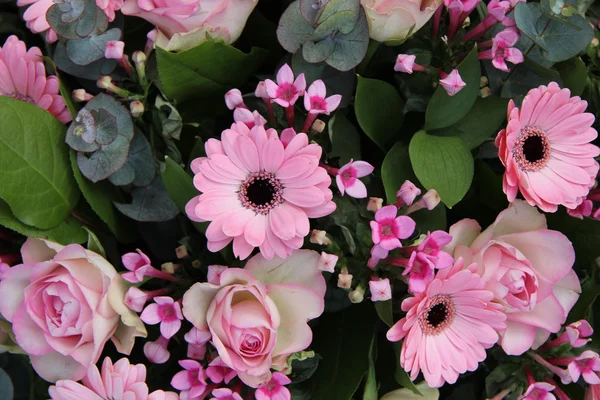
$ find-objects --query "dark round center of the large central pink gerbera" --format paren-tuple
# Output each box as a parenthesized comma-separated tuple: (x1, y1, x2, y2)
(239, 172, 283, 214)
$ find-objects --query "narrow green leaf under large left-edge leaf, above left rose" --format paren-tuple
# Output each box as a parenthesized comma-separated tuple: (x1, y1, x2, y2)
(0, 200, 87, 245)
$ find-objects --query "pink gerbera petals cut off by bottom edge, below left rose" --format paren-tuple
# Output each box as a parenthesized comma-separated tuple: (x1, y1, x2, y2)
(48, 357, 179, 400)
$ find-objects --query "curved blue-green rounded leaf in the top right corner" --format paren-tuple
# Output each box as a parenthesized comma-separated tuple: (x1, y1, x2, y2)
(514, 3, 594, 62)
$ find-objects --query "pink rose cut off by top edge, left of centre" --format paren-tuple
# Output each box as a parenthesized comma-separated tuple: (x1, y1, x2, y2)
(121, 0, 258, 51)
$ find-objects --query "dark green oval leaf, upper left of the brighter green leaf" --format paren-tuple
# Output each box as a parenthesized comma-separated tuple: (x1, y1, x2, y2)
(354, 76, 406, 150)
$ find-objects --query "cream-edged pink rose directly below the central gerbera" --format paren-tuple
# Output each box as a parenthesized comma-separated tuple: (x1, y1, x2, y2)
(183, 250, 325, 387)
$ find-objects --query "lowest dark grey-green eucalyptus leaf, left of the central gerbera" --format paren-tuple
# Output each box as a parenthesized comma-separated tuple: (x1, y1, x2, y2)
(115, 175, 179, 222)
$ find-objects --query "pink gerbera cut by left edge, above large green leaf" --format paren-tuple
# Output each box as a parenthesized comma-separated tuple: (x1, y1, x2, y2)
(0, 35, 71, 123)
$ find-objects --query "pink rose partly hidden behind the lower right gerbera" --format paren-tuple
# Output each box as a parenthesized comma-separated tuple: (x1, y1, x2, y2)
(443, 200, 581, 355)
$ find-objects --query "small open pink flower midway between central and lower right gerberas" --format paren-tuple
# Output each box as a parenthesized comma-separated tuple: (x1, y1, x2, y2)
(370, 206, 415, 251)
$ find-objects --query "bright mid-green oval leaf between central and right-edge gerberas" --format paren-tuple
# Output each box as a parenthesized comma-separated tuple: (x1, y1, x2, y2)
(408, 131, 473, 208)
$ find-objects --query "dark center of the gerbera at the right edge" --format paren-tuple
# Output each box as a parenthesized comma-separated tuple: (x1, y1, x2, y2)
(512, 126, 550, 171)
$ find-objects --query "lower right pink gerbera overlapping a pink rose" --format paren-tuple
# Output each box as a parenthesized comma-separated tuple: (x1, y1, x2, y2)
(387, 258, 506, 387)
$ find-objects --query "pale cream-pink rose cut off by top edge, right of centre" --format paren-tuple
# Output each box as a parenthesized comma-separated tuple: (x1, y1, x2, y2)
(360, 0, 442, 44)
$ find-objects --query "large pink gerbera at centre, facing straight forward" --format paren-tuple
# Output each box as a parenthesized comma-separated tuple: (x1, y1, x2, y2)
(186, 122, 335, 259)
